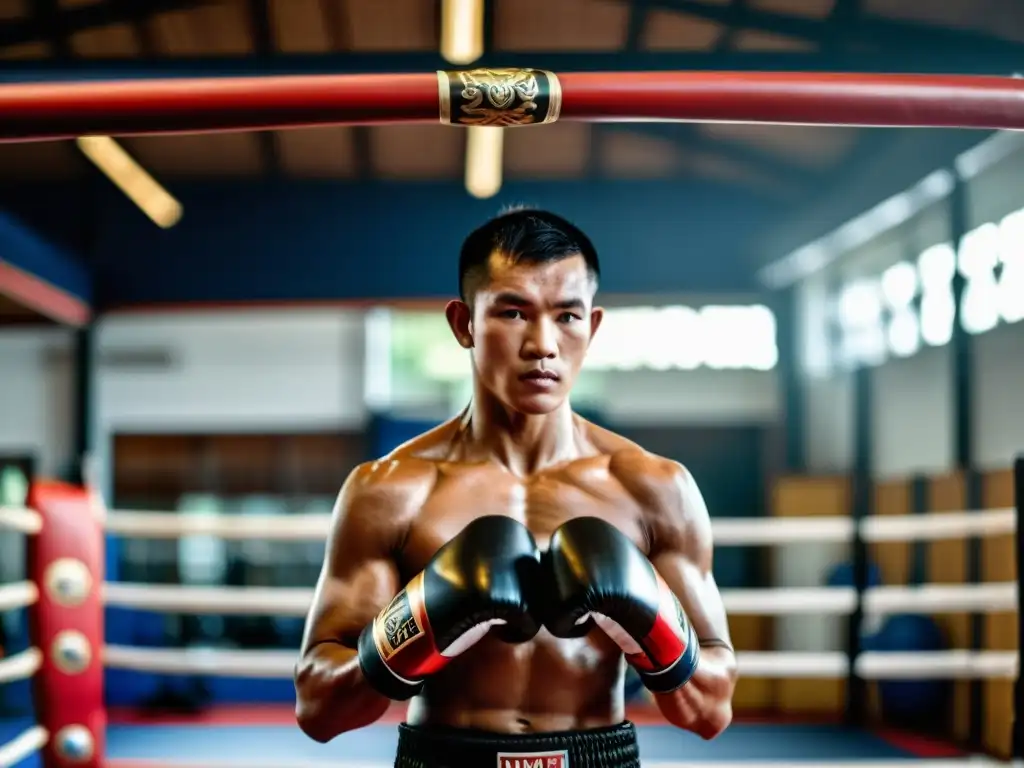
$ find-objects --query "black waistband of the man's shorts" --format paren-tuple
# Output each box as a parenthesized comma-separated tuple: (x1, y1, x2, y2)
(395, 721, 640, 768)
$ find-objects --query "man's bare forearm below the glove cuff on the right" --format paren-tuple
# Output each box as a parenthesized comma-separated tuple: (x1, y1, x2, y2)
(654, 645, 736, 738)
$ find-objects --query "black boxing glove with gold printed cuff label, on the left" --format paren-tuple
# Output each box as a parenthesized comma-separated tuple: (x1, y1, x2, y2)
(357, 516, 541, 701)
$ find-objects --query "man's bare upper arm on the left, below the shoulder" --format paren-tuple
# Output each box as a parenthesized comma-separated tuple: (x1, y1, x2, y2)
(303, 479, 399, 649)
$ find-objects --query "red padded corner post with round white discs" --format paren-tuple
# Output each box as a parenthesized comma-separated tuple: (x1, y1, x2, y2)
(27, 481, 106, 768)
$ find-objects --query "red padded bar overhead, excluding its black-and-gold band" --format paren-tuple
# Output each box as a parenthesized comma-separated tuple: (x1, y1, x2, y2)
(0, 70, 1024, 141)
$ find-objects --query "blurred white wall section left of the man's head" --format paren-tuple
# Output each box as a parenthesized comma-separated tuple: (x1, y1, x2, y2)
(95, 309, 367, 499)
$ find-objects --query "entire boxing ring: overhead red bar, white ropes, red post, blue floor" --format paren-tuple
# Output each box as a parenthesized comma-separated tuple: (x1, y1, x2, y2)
(0, 70, 1024, 768)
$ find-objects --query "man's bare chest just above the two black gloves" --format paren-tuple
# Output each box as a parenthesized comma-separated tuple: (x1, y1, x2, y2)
(401, 462, 646, 572)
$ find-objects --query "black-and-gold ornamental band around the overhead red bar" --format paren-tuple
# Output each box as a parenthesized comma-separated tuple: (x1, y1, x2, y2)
(437, 69, 562, 128)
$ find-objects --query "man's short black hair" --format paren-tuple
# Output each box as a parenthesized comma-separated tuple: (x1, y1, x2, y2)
(459, 207, 601, 301)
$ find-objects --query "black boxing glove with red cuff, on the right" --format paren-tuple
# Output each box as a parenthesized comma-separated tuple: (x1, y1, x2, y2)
(545, 517, 700, 693)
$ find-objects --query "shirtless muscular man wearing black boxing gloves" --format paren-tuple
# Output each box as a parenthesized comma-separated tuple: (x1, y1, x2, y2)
(295, 209, 736, 768)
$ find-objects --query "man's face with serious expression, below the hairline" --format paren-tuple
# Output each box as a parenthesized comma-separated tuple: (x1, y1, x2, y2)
(456, 254, 601, 414)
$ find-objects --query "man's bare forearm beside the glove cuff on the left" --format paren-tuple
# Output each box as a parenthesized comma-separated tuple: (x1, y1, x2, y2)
(295, 643, 391, 742)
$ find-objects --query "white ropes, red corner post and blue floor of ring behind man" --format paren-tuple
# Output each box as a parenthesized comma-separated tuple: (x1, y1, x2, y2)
(0, 465, 1024, 768)
